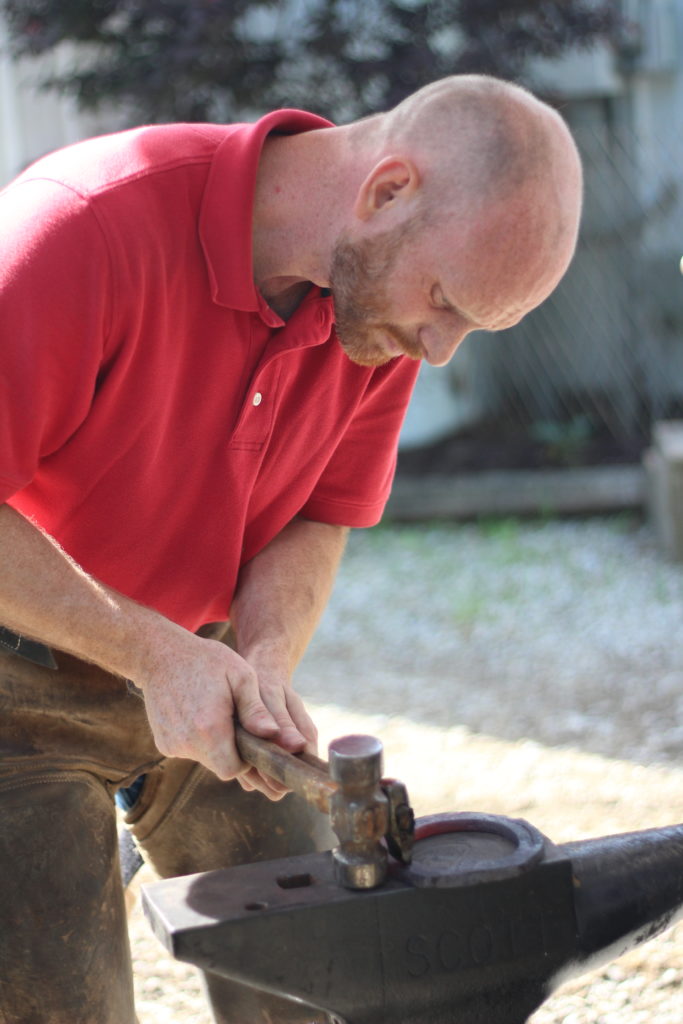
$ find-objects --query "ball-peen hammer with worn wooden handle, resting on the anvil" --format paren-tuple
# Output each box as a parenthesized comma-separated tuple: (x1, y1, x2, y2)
(234, 725, 415, 889)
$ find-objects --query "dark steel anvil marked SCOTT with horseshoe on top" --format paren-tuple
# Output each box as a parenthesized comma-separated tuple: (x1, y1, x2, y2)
(143, 814, 683, 1024)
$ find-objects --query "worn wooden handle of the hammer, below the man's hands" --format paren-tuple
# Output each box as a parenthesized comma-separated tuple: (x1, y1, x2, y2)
(234, 723, 338, 814)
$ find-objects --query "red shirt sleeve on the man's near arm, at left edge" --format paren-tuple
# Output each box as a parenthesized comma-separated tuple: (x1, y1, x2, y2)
(0, 179, 111, 502)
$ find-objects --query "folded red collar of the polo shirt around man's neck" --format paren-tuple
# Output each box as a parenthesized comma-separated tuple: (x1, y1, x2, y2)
(199, 110, 331, 327)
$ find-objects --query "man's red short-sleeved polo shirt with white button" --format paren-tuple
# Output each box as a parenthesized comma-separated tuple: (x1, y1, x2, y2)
(0, 111, 417, 629)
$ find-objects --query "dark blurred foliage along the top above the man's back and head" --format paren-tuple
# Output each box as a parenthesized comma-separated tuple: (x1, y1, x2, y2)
(0, 0, 618, 122)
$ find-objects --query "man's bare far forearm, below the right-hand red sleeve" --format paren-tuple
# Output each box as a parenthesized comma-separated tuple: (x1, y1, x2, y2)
(230, 518, 348, 675)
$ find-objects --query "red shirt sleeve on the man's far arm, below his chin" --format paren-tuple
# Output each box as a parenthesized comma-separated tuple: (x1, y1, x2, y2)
(300, 357, 420, 527)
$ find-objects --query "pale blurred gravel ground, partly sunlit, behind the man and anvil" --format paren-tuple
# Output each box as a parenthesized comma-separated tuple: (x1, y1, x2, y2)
(131, 517, 683, 1024)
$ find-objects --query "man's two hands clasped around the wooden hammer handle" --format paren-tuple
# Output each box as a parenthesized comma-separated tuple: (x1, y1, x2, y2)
(134, 633, 316, 800)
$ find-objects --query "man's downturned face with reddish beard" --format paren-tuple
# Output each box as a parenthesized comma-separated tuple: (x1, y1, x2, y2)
(330, 197, 564, 367)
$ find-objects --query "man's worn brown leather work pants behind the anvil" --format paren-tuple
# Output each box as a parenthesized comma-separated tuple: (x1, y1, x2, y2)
(0, 634, 333, 1024)
